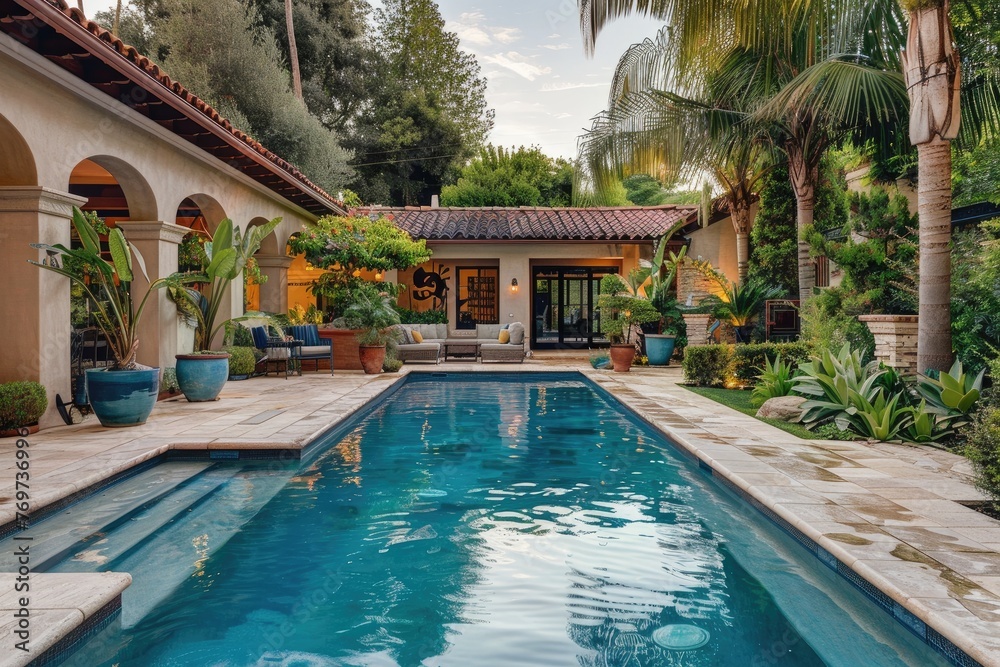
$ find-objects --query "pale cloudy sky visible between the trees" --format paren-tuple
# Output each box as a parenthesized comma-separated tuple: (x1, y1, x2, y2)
(84, 0, 660, 158)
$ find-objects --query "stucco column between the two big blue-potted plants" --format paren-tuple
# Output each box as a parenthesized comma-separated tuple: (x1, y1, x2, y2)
(115, 220, 190, 368)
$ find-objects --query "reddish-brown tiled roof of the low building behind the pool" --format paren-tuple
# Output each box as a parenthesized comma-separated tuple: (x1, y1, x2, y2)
(357, 206, 698, 241)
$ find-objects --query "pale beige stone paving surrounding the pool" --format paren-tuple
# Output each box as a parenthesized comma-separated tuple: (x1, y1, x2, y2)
(0, 362, 1000, 666)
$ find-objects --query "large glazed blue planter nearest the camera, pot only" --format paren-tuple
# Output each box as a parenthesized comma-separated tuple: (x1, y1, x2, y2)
(86, 368, 160, 428)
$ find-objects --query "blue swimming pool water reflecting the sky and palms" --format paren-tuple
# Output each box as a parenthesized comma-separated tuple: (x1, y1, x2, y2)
(33, 374, 944, 667)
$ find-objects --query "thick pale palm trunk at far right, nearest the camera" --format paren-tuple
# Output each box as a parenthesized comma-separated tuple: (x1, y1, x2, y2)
(903, 0, 961, 372)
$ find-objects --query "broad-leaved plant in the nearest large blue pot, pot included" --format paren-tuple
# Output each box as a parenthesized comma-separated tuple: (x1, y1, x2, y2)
(29, 207, 163, 427)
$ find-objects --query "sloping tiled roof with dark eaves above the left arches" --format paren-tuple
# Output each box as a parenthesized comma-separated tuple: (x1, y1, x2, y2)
(0, 0, 342, 215)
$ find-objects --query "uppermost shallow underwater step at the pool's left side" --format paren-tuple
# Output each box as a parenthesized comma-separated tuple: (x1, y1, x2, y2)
(0, 461, 212, 572)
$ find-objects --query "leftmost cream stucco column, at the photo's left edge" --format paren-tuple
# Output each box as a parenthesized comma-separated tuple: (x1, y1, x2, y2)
(0, 187, 87, 428)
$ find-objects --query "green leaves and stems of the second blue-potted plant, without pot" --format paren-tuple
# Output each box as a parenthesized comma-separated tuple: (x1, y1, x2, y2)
(165, 218, 281, 351)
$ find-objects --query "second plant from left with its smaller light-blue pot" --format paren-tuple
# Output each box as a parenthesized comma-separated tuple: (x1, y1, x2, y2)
(164, 218, 281, 402)
